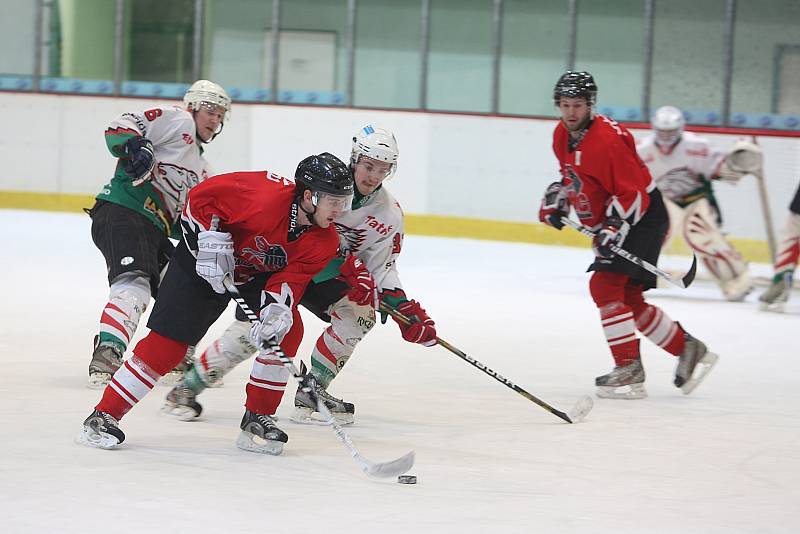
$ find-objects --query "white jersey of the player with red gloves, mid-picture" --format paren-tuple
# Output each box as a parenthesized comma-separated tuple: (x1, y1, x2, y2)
(335, 187, 403, 291)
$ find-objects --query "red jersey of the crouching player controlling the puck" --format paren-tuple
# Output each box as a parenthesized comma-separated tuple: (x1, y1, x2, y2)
(181, 171, 339, 304)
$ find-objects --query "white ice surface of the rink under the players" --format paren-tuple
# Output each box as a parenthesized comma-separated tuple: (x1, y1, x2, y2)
(0, 210, 800, 534)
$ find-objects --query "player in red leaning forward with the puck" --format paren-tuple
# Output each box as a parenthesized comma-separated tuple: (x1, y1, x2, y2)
(77, 153, 353, 454)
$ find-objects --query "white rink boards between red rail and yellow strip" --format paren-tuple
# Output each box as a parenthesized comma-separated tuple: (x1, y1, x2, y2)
(0, 93, 800, 239)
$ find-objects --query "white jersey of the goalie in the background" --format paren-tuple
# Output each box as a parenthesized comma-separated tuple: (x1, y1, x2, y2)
(636, 132, 725, 202)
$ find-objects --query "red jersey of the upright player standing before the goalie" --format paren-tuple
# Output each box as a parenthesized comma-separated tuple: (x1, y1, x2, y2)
(553, 115, 655, 229)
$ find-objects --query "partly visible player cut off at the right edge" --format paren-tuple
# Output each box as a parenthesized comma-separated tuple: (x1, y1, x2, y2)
(758, 182, 800, 312)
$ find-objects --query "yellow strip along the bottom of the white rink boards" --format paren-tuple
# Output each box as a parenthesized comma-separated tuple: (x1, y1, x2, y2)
(0, 191, 771, 263)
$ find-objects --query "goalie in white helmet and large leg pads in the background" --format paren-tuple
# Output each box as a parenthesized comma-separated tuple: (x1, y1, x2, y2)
(637, 106, 758, 301)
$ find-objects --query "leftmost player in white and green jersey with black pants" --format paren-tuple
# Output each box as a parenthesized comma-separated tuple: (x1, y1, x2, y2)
(86, 80, 231, 388)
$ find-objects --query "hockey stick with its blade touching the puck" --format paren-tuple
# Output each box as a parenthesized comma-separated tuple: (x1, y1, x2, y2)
(223, 278, 414, 478)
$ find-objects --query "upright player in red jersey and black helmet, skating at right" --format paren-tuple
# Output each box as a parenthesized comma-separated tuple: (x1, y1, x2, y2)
(539, 72, 717, 399)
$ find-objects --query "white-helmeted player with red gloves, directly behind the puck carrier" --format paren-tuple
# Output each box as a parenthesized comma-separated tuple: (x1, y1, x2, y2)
(164, 126, 436, 424)
